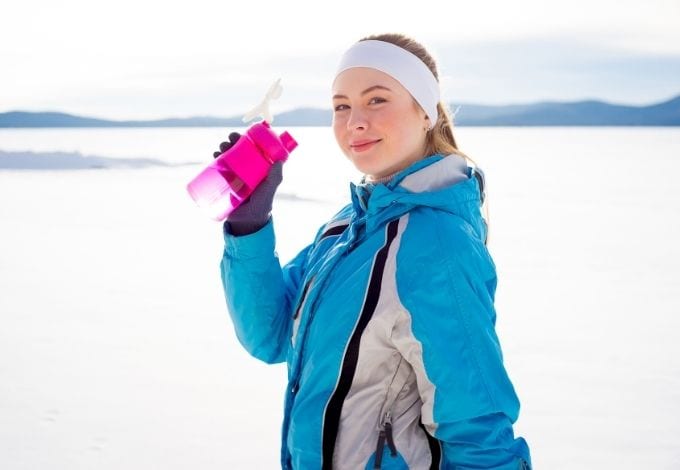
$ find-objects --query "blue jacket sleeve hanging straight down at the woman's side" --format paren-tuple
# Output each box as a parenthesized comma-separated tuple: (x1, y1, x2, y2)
(393, 217, 531, 470)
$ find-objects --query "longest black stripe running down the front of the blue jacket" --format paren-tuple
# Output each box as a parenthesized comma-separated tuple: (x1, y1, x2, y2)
(322, 220, 399, 470)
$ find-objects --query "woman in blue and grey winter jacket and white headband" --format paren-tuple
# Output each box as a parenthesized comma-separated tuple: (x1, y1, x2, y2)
(221, 35, 530, 470)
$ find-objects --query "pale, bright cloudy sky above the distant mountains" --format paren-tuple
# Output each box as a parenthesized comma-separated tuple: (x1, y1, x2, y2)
(0, 0, 680, 119)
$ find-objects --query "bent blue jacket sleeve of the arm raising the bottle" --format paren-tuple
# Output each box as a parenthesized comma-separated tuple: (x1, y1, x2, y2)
(221, 220, 311, 364)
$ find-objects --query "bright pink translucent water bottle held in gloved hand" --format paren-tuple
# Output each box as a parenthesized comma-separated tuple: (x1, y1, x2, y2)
(187, 121, 297, 221)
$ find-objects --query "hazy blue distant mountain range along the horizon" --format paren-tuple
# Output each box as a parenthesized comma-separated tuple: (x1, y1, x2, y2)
(0, 95, 680, 128)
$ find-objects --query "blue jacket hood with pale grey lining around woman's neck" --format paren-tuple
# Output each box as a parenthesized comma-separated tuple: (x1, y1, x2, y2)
(351, 155, 486, 240)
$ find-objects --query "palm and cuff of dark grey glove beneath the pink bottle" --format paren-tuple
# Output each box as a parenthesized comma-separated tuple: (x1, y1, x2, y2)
(224, 161, 283, 236)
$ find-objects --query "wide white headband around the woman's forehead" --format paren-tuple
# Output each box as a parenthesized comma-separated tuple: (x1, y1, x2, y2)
(335, 40, 439, 129)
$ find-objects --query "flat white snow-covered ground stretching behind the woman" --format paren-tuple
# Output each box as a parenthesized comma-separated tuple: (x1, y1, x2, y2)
(0, 128, 680, 470)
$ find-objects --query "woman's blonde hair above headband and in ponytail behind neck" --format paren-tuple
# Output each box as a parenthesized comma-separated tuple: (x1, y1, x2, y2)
(359, 33, 489, 239)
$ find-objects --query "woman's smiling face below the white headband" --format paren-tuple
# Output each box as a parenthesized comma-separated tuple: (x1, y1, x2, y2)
(333, 67, 429, 179)
